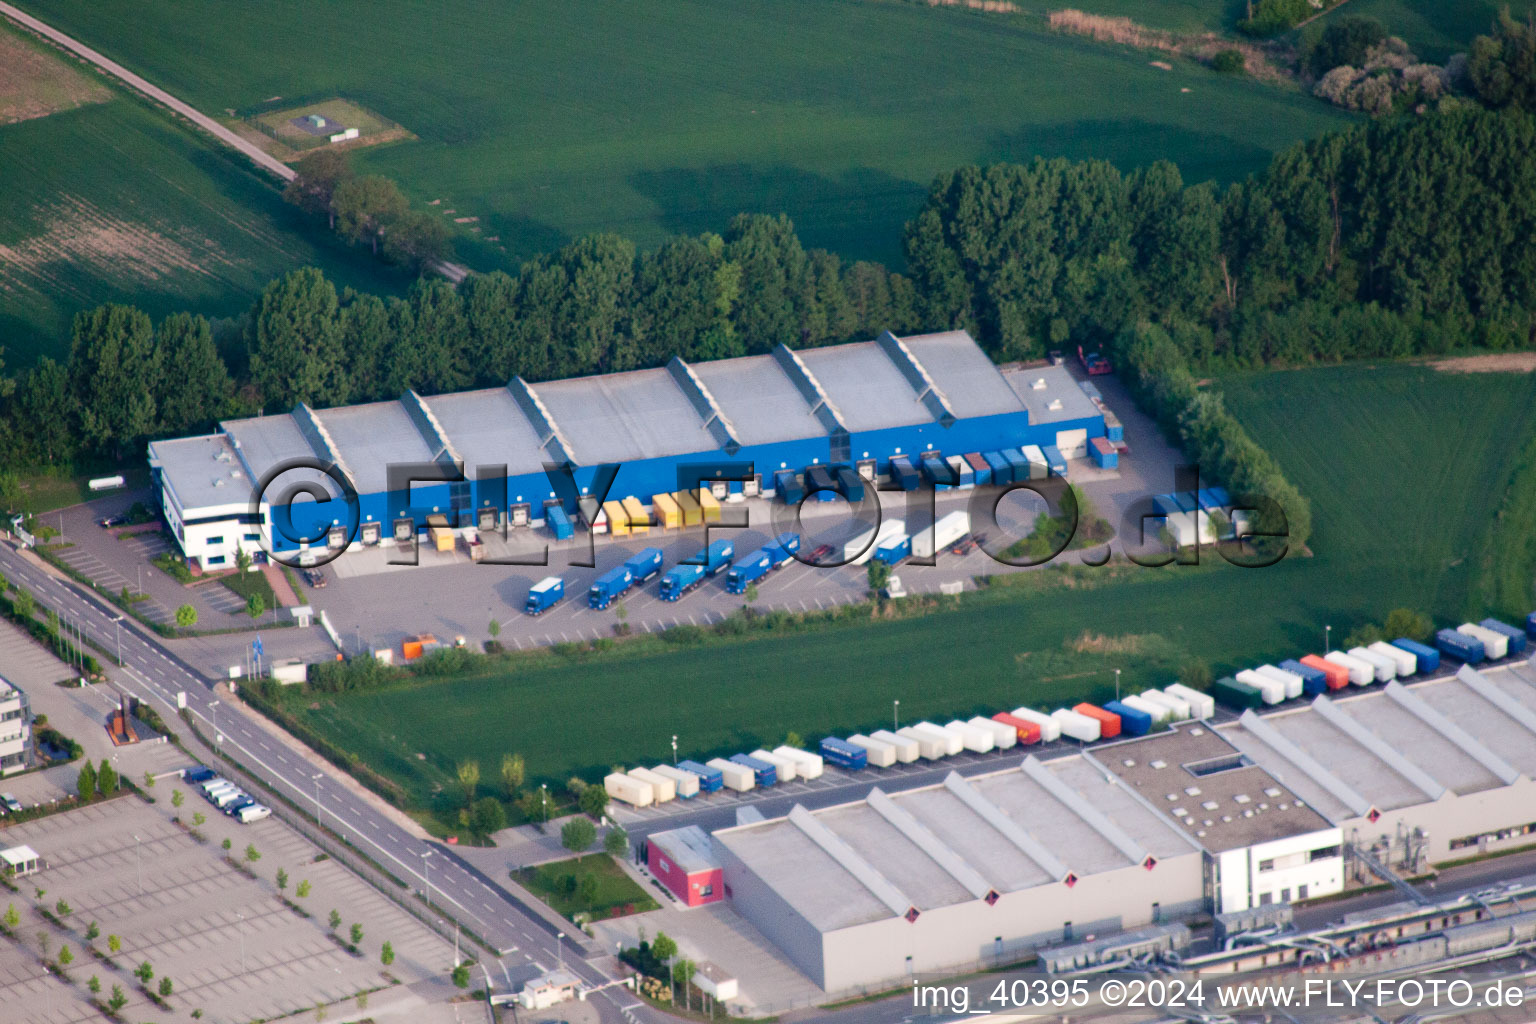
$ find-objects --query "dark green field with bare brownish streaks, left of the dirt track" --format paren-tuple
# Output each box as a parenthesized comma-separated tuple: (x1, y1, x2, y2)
(0, 82, 399, 368)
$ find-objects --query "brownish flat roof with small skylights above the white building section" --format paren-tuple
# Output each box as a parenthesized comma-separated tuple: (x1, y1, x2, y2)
(1094, 723, 1329, 854)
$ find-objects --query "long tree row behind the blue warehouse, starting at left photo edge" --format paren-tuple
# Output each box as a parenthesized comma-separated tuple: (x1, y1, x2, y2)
(0, 215, 919, 465)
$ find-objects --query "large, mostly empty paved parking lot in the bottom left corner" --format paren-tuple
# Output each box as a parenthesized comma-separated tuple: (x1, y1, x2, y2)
(0, 780, 453, 1022)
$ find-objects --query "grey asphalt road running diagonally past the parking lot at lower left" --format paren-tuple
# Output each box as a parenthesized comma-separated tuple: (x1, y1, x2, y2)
(0, 543, 650, 1024)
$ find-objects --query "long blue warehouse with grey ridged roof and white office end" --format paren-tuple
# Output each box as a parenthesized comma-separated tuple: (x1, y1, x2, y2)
(149, 332, 1104, 568)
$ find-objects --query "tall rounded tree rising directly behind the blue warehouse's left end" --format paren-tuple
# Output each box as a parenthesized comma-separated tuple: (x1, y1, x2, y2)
(249, 267, 349, 411)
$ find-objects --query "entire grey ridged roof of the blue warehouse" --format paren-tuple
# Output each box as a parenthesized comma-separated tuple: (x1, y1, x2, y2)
(162, 332, 1050, 507)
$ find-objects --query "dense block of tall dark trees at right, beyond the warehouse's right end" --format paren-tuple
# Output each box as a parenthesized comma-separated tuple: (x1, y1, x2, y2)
(905, 103, 1536, 368)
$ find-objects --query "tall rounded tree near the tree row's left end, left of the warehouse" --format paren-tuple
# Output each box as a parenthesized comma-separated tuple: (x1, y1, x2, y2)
(69, 304, 161, 451)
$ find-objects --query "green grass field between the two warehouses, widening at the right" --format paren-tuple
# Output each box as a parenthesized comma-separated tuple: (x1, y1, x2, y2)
(286, 365, 1536, 806)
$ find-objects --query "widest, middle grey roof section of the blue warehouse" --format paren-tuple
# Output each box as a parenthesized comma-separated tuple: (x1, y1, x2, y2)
(533, 370, 720, 465)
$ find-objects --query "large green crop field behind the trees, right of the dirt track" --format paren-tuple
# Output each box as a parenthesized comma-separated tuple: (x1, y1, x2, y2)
(14, 0, 1346, 267)
